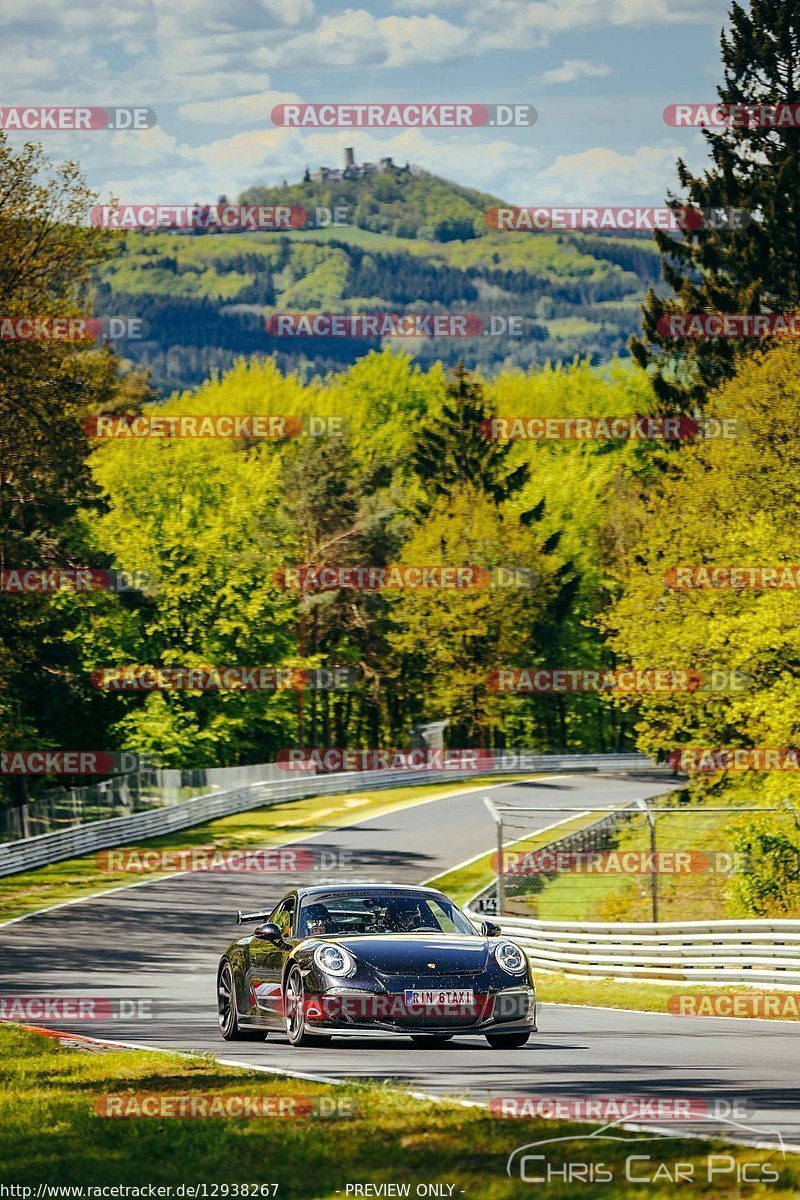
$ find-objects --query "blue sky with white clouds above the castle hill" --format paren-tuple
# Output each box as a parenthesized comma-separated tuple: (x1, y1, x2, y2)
(0, 0, 727, 205)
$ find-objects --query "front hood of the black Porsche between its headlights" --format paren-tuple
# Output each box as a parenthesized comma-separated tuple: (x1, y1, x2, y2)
(329, 934, 489, 979)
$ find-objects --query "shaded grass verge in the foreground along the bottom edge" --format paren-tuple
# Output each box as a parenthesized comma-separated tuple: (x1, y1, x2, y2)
(0, 1026, 800, 1200)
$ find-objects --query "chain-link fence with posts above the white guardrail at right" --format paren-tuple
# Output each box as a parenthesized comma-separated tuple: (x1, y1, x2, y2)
(470, 796, 800, 924)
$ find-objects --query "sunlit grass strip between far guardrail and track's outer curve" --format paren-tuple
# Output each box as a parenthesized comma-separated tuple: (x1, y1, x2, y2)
(0, 775, 530, 922)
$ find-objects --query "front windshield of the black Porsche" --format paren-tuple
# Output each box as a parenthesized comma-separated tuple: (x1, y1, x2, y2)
(297, 892, 475, 937)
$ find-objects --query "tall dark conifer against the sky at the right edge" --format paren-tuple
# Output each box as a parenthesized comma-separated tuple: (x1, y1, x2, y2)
(631, 0, 800, 413)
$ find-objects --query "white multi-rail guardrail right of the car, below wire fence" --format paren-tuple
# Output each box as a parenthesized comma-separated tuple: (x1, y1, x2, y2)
(468, 908, 800, 986)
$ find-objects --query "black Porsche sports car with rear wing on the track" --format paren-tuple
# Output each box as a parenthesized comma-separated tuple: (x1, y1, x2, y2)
(217, 884, 536, 1046)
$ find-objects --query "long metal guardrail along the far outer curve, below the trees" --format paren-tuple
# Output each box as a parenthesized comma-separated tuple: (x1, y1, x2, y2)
(0, 751, 672, 876)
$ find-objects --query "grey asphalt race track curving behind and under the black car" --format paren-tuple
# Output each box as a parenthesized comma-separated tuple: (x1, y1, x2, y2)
(0, 775, 800, 1147)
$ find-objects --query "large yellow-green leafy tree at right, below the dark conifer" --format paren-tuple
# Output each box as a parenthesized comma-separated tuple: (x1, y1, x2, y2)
(607, 342, 800, 798)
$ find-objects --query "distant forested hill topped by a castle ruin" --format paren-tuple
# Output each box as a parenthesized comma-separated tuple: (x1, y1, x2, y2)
(94, 169, 660, 394)
